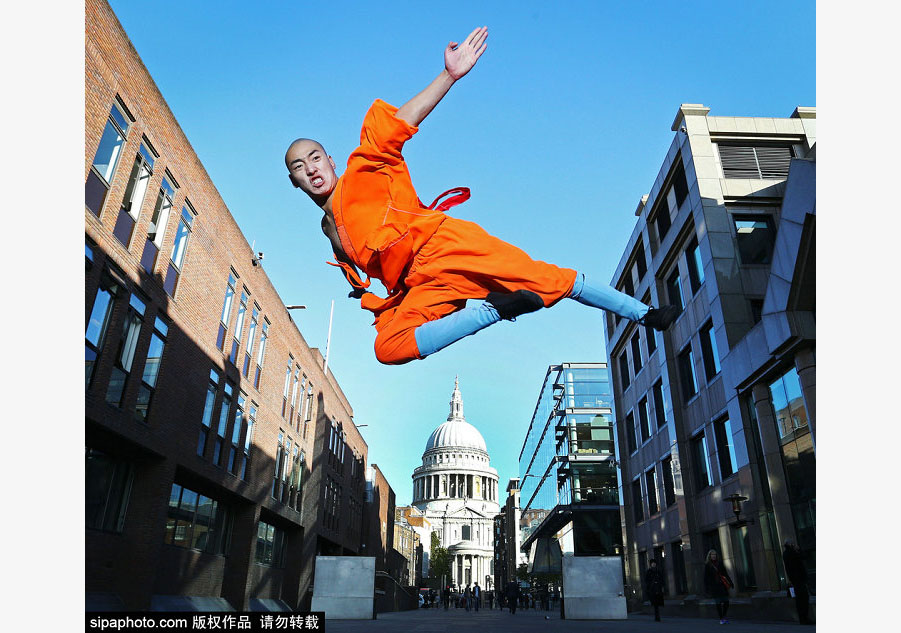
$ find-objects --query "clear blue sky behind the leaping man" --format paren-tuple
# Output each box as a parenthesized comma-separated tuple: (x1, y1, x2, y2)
(111, 0, 817, 504)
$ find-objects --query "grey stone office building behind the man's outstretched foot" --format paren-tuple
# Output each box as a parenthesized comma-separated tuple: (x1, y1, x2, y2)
(605, 104, 816, 596)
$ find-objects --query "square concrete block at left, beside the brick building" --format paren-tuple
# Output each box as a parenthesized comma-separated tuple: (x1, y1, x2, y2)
(312, 556, 375, 620)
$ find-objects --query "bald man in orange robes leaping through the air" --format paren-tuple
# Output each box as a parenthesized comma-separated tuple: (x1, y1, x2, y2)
(285, 27, 679, 365)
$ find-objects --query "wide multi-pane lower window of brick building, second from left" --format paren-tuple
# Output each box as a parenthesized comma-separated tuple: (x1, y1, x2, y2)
(165, 483, 231, 554)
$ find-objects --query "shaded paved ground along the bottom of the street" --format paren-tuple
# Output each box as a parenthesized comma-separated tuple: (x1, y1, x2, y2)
(326, 608, 816, 633)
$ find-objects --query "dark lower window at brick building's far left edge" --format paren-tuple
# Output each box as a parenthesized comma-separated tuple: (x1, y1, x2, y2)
(84, 448, 134, 532)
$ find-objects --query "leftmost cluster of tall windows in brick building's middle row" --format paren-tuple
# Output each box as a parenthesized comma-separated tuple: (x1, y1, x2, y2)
(84, 260, 169, 422)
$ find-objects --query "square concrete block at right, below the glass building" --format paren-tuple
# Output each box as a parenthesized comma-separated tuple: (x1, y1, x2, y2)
(563, 556, 627, 620)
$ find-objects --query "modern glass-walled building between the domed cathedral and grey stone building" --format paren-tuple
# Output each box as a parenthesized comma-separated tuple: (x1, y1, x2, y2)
(508, 363, 622, 571)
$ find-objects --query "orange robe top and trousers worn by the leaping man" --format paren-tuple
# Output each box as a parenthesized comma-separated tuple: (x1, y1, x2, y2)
(332, 100, 576, 364)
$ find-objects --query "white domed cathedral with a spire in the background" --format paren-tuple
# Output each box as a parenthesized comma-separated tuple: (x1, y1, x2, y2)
(413, 380, 499, 589)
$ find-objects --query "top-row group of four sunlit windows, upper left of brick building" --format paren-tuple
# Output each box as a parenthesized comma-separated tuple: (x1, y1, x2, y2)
(85, 96, 197, 297)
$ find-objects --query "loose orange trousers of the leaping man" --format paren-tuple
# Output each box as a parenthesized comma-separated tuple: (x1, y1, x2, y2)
(375, 217, 576, 365)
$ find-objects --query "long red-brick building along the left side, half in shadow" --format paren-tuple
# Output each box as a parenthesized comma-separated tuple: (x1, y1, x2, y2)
(84, 0, 367, 609)
